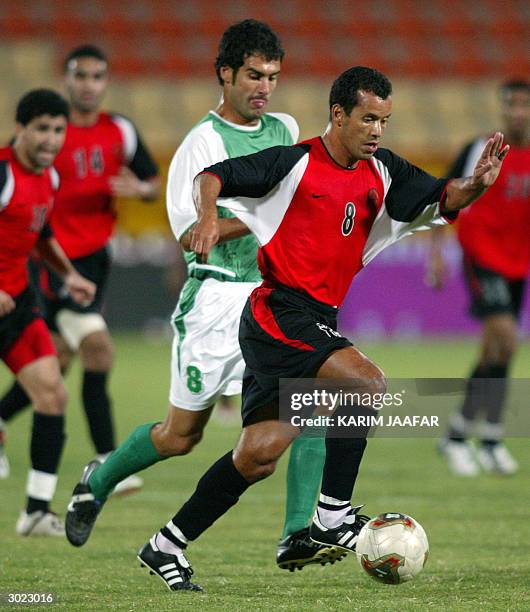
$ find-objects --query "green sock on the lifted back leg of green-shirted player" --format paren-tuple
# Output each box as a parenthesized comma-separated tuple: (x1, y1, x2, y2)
(88, 423, 166, 501)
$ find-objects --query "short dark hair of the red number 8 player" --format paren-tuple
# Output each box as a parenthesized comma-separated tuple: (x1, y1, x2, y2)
(329, 66, 392, 115)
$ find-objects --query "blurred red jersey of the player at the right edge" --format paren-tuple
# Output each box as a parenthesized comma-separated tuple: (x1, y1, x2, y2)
(449, 138, 530, 280)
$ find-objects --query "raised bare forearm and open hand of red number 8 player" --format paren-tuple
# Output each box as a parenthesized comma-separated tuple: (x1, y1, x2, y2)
(442, 132, 510, 213)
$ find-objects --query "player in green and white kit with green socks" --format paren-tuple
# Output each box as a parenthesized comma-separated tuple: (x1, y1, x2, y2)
(66, 19, 343, 570)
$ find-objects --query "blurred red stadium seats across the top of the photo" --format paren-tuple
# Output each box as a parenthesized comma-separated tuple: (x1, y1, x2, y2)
(0, 0, 530, 78)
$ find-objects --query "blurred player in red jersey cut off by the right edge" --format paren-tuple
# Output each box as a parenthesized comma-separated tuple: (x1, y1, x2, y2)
(431, 81, 530, 476)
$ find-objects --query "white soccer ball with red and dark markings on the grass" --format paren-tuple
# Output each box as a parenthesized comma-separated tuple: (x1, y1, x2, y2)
(356, 512, 429, 584)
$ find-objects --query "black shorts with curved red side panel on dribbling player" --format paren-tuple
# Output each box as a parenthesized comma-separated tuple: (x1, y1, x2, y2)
(239, 286, 352, 427)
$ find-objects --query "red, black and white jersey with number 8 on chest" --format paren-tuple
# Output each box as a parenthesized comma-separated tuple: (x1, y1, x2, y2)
(205, 138, 448, 308)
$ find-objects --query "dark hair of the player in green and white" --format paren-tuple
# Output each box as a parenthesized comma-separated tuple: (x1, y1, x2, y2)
(215, 19, 285, 85)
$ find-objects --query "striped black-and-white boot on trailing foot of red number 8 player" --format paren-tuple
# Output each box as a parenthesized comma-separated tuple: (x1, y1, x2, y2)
(137, 535, 203, 591)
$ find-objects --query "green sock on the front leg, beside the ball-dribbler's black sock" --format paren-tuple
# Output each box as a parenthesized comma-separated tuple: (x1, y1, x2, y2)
(282, 435, 326, 539)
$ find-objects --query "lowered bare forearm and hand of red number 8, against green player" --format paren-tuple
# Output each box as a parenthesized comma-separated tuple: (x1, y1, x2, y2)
(189, 173, 221, 262)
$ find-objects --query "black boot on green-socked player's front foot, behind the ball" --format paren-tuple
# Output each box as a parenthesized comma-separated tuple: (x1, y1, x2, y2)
(276, 527, 346, 572)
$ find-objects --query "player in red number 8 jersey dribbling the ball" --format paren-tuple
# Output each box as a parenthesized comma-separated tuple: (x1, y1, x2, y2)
(69, 67, 508, 590)
